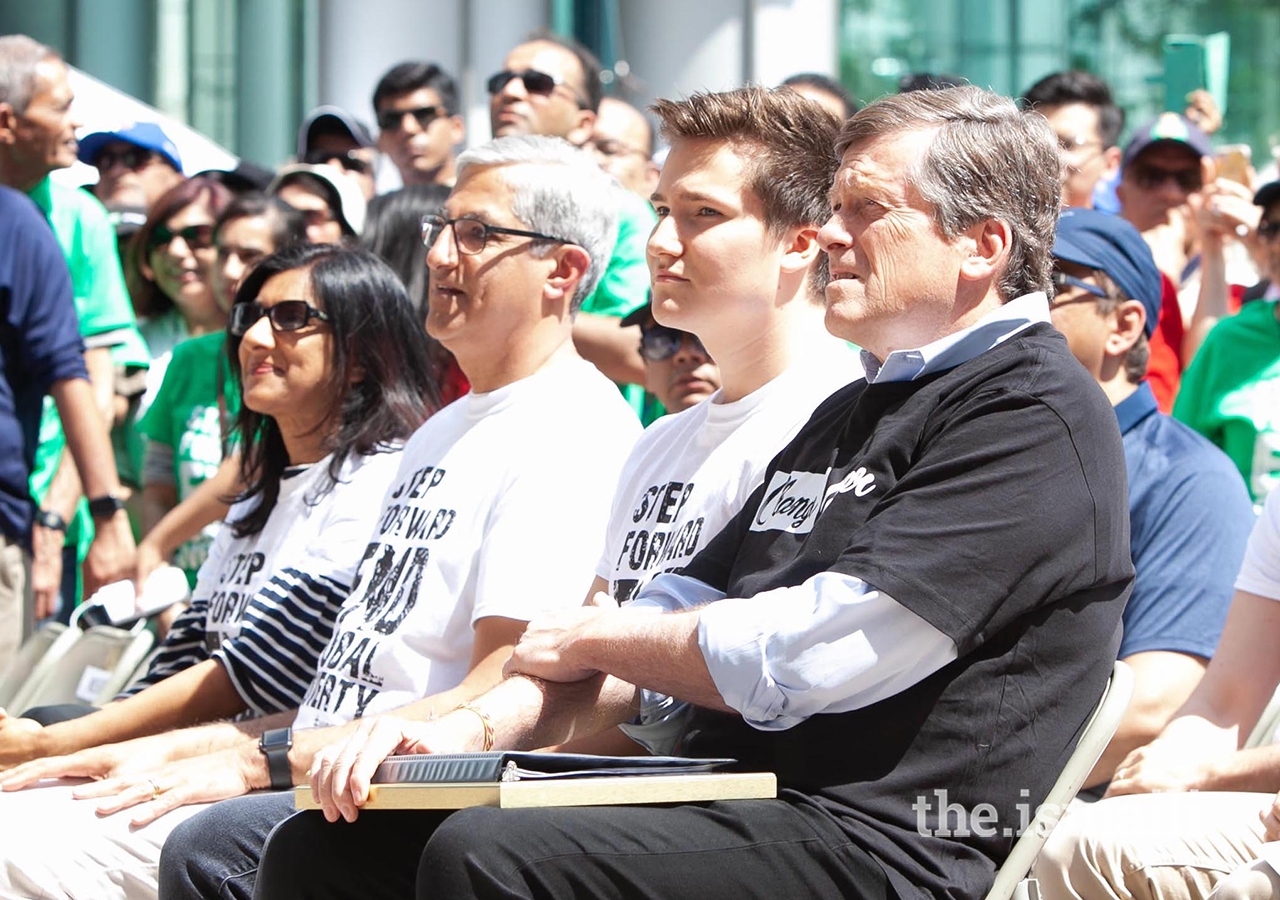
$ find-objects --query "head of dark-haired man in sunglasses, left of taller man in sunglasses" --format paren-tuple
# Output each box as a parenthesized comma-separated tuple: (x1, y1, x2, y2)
(374, 61, 467, 193)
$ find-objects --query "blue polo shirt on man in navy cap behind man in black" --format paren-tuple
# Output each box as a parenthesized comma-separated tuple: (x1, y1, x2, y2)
(1115, 382, 1253, 658)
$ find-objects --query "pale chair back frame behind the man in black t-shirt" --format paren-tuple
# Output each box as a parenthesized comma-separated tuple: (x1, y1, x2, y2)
(986, 661, 1133, 900)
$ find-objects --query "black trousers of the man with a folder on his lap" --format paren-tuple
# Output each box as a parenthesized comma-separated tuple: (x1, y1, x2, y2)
(238, 800, 895, 900)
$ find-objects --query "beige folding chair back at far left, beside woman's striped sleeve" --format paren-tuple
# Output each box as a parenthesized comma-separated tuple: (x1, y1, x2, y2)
(13, 622, 155, 711)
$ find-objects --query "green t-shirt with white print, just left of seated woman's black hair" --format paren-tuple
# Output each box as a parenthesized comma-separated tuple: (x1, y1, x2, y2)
(138, 332, 239, 585)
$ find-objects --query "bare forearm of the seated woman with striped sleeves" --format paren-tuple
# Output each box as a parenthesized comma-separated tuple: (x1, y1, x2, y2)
(41, 659, 244, 755)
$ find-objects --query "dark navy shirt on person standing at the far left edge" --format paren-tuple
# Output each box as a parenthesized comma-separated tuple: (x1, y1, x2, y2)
(0, 187, 88, 543)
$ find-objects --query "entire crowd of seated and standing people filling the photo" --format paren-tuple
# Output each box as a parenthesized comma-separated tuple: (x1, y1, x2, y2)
(0, 17, 1280, 900)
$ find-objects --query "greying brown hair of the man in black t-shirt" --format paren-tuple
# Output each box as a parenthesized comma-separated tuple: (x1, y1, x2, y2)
(836, 86, 1062, 301)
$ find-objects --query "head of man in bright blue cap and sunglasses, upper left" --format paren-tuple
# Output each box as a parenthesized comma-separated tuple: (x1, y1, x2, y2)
(78, 122, 182, 215)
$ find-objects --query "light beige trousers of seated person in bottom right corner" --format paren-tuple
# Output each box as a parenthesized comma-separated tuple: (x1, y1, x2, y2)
(1034, 792, 1275, 900)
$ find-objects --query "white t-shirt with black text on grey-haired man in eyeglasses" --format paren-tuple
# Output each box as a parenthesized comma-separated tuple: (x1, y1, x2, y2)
(294, 357, 640, 727)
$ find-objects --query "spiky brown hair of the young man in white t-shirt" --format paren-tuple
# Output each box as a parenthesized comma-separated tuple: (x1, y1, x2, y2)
(649, 87, 840, 237)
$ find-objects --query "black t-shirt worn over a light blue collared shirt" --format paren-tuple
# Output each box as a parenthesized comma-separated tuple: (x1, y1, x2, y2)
(681, 325, 1133, 900)
